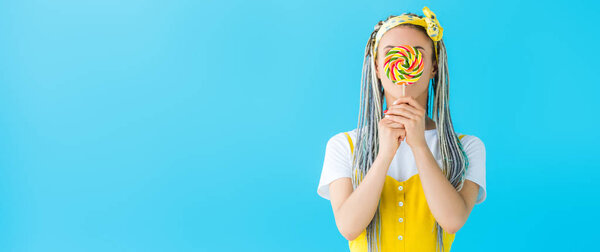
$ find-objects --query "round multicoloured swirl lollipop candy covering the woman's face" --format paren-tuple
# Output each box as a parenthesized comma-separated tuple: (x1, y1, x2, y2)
(383, 45, 425, 85)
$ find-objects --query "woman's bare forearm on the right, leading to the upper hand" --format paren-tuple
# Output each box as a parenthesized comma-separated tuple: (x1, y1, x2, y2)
(412, 145, 467, 233)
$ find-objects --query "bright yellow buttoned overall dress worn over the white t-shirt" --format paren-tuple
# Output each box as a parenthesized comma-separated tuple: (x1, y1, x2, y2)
(344, 132, 464, 252)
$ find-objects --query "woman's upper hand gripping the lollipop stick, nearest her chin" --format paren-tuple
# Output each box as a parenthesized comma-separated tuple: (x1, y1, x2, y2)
(385, 96, 427, 148)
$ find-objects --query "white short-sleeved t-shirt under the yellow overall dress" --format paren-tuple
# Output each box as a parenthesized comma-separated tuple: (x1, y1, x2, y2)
(317, 129, 486, 204)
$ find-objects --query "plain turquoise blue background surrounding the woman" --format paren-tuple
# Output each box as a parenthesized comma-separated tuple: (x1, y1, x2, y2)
(0, 0, 600, 251)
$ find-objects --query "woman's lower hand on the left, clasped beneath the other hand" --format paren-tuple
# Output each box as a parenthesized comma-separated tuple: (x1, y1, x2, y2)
(377, 117, 406, 156)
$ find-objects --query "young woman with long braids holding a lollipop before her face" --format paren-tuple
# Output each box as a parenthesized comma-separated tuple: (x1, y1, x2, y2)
(317, 7, 486, 252)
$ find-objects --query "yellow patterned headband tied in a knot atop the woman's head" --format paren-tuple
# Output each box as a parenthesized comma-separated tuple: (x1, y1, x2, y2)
(372, 6, 444, 60)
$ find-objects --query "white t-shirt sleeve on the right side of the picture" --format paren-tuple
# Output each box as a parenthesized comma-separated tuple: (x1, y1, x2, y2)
(461, 135, 486, 204)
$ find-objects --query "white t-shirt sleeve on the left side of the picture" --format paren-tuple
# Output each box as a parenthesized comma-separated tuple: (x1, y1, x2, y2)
(317, 132, 352, 200)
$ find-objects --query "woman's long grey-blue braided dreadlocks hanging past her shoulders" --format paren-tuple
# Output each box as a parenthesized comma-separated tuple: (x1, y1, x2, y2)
(352, 13, 469, 252)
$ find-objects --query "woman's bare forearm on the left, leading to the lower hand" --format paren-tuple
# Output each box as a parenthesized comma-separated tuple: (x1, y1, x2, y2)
(338, 154, 393, 240)
